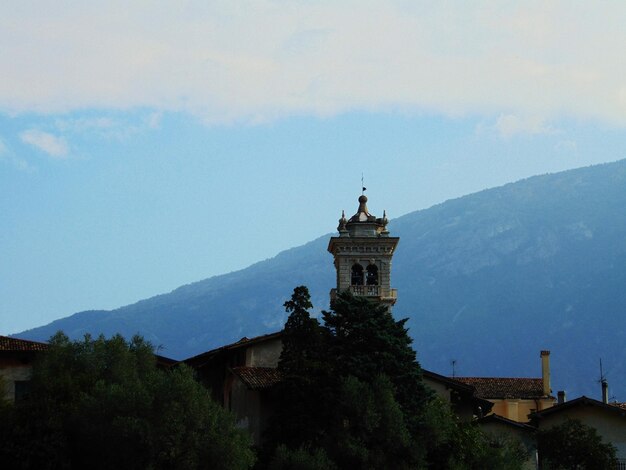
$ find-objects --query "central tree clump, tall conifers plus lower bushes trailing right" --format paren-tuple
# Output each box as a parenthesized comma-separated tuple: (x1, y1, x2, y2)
(266, 287, 525, 470)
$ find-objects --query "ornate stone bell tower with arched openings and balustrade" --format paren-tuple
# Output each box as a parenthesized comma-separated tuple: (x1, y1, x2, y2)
(328, 195, 400, 310)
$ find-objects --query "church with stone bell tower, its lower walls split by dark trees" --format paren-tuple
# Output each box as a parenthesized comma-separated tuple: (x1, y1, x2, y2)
(184, 195, 492, 444)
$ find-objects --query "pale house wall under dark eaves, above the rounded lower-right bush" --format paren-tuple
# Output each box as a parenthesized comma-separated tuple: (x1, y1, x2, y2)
(538, 406, 626, 459)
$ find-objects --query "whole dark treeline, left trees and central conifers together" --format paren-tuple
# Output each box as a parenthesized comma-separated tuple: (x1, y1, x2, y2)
(0, 287, 525, 470)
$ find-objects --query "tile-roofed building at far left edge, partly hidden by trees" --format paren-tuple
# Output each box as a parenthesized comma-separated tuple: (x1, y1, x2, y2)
(0, 336, 48, 401)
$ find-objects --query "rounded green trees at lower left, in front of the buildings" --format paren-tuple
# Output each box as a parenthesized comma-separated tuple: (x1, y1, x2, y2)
(0, 333, 254, 469)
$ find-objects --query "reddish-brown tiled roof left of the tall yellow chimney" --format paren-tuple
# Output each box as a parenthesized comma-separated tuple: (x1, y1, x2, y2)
(455, 377, 545, 398)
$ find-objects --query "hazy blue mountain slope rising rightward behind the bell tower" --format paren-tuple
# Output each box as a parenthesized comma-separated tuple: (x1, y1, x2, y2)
(17, 160, 626, 401)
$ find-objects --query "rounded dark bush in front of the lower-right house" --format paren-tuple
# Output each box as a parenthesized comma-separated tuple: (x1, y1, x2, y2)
(537, 419, 617, 470)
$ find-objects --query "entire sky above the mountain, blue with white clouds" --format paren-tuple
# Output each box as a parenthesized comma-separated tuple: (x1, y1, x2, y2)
(0, 1, 626, 334)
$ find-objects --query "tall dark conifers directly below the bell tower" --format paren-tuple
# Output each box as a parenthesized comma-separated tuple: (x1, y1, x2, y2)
(267, 287, 430, 468)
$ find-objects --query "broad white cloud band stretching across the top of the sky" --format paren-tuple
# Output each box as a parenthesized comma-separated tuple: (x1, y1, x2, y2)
(0, 0, 626, 128)
